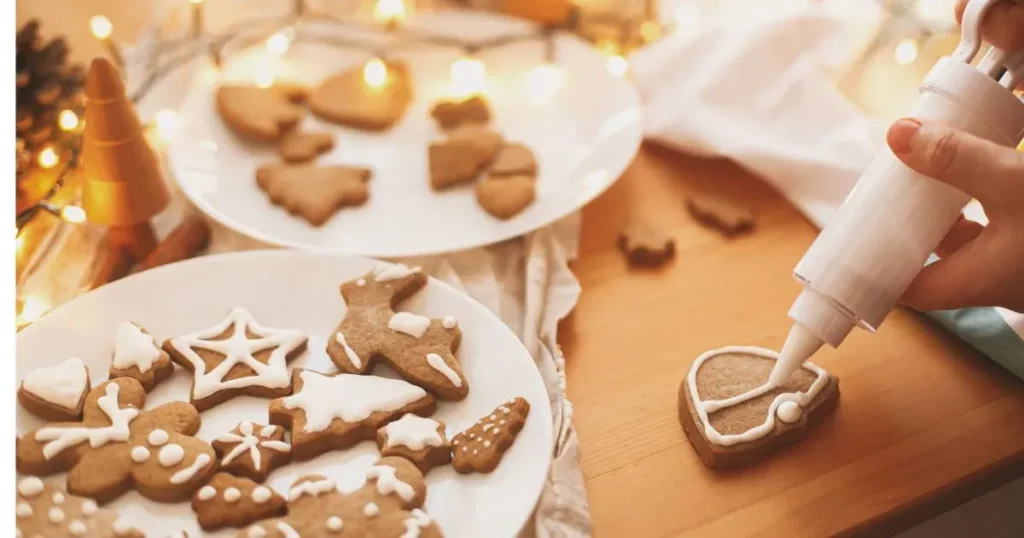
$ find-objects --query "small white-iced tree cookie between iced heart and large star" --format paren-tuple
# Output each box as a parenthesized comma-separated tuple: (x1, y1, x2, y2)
(110, 322, 174, 392)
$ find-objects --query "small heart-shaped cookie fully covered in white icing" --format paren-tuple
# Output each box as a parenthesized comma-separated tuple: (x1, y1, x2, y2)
(17, 357, 89, 420)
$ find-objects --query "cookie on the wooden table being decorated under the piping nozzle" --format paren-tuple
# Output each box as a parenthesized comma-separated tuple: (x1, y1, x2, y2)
(679, 346, 839, 467)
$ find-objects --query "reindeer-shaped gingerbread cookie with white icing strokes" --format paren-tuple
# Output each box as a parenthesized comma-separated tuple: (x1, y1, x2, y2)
(327, 263, 469, 400)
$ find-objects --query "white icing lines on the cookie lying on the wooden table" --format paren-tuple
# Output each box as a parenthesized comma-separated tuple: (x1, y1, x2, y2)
(686, 345, 828, 447)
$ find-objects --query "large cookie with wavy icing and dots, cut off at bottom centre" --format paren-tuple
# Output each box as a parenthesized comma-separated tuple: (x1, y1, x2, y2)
(244, 458, 442, 538)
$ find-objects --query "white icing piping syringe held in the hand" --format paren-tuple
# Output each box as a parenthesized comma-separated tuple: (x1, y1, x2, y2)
(769, 0, 1024, 384)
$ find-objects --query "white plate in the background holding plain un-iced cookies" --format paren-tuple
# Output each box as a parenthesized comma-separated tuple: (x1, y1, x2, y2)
(169, 11, 641, 257)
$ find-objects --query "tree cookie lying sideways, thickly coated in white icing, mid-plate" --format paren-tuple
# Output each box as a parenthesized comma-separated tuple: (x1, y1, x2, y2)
(270, 370, 435, 460)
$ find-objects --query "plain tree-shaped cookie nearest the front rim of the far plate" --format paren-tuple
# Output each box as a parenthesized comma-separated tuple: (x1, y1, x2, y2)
(256, 164, 372, 226)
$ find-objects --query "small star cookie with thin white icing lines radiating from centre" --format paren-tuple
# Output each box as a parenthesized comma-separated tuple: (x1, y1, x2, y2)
(213, 420, 292, 483)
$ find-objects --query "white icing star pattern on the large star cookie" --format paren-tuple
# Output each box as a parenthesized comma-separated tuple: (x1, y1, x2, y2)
(171, 308, 306, 400)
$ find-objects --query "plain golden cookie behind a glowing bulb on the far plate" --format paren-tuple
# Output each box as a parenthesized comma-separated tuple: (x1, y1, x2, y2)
(307, 61, 413, 131)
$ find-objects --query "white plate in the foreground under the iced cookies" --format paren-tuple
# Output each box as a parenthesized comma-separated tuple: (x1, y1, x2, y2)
(17, 250, 552, 538)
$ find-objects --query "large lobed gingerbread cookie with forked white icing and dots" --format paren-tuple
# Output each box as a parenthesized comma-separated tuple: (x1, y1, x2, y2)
(16, 377, 217, 503)
